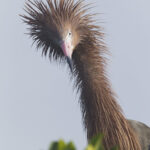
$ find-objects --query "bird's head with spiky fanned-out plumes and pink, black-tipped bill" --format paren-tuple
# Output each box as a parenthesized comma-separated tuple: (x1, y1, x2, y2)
(21, 0, 101, 70)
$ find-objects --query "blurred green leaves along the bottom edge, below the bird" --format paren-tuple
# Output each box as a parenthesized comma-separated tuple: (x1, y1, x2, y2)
(49, 135, 118, 150)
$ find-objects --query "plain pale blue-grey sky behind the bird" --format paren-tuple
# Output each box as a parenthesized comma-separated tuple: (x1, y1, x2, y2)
(0, 0, 150, 150)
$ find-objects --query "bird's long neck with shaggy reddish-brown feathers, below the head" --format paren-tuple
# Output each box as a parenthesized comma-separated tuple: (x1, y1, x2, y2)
(74, 47, 140, 150)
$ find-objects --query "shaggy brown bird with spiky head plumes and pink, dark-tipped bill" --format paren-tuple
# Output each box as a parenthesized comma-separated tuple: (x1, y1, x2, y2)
(21, 0, 150, 150)
